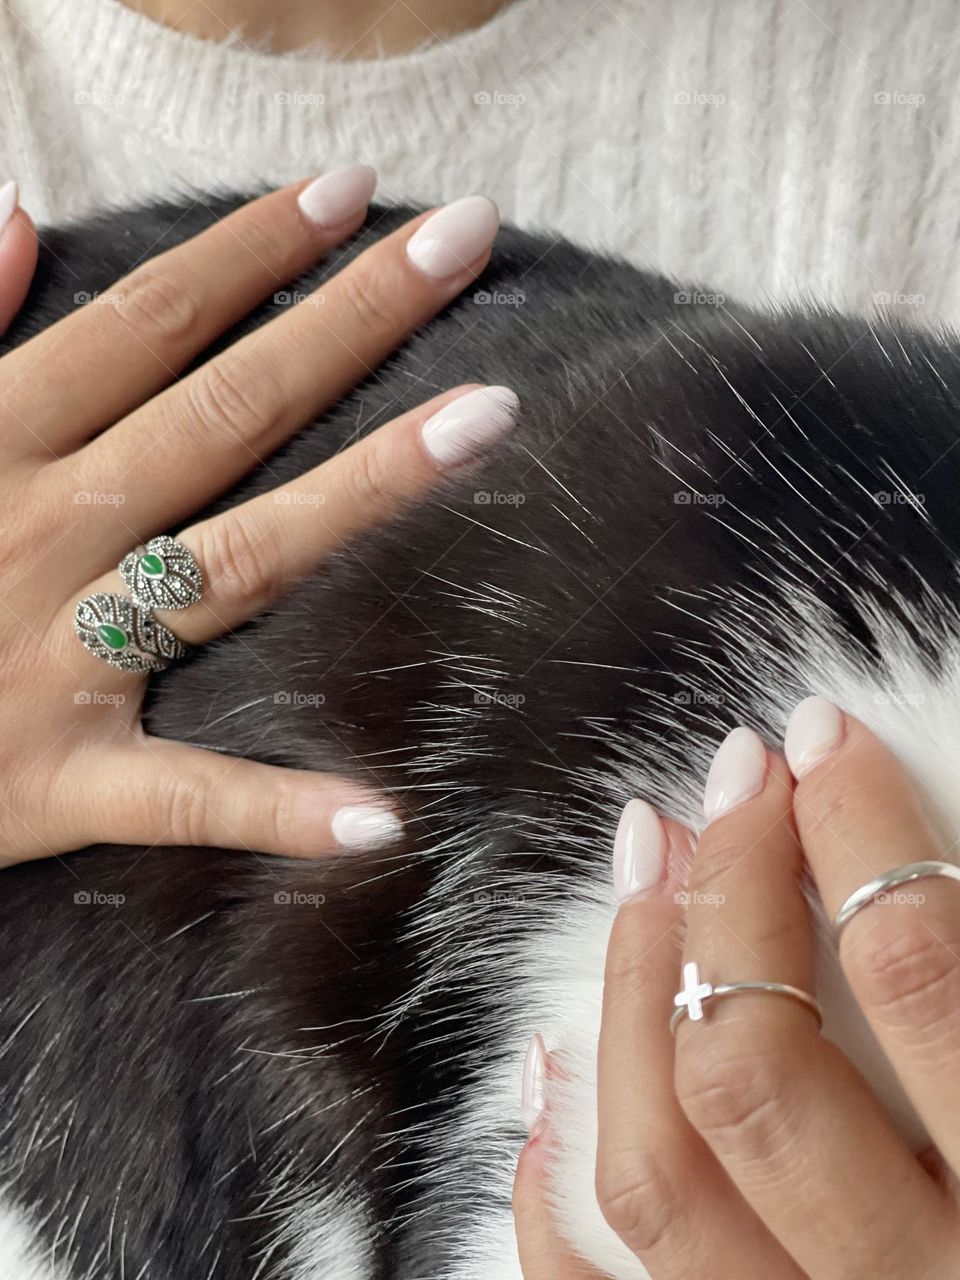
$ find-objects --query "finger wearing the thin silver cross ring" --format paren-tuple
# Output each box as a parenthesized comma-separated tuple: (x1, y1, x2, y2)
(676, 728, 956, 1280)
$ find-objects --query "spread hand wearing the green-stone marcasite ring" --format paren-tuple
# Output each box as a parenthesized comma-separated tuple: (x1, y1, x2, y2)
(0, 166, 516, 864)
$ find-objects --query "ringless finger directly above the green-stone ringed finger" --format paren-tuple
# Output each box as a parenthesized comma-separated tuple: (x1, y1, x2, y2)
(70, 197, 498, 554)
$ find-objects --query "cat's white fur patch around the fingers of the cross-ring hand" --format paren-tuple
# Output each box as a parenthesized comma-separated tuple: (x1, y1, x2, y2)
(449, 590, 960, 1280)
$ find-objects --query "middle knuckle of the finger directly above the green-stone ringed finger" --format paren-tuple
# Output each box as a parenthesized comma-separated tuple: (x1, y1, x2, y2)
(186, 358, 282, 449)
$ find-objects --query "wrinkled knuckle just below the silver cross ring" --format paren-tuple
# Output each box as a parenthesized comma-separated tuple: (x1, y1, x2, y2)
(675, 1023, 788, 1155)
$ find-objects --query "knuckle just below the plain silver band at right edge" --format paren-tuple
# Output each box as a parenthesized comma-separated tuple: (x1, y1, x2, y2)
(846, 909, 960, 1032)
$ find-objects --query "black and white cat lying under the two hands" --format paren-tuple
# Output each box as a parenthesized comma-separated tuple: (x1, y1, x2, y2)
(0, 200, 960, 1280)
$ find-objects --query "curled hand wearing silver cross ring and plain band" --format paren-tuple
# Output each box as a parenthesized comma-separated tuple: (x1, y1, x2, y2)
(521, 699, 960, 1280)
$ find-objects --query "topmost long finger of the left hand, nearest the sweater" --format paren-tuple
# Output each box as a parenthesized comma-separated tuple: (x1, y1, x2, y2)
(0, 165, 375, 455)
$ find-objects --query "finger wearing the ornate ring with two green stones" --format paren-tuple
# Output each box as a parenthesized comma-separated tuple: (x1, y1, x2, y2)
(126, 387, 517, 644)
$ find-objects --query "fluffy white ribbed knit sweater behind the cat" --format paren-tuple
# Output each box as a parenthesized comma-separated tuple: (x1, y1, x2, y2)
(0, 0, 960, 323)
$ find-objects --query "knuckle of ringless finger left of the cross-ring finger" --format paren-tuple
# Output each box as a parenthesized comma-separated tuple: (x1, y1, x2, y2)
(596, 1149, 681, 1254)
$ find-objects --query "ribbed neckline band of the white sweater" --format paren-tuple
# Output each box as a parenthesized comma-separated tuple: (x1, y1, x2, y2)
(31, 0, 589, 155)
